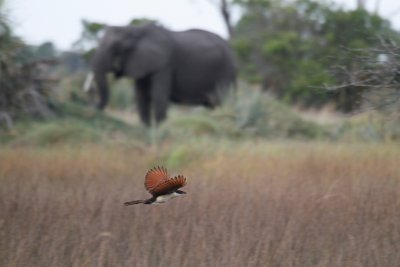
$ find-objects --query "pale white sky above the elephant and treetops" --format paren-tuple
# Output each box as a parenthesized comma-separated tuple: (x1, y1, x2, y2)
(6, 0, 400, 49)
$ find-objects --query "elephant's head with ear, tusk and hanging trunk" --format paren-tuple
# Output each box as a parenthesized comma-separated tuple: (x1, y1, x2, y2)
(92, 24, 172, 109)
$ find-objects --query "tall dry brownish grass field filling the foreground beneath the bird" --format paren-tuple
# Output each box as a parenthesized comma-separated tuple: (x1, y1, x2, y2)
(0, 142, 400, 267)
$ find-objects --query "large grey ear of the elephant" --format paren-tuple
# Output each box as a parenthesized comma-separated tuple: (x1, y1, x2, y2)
(126, 27, 173, 78)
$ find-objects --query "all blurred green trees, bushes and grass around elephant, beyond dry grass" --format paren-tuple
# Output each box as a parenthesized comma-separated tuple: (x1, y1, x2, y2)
(0, 0, 400, 147)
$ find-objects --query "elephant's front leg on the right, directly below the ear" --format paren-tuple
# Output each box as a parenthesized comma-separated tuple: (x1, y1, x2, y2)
(151, 70, 171, 125)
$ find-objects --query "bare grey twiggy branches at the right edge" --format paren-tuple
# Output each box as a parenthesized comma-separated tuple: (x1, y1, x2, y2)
(327, 39, 400, 118)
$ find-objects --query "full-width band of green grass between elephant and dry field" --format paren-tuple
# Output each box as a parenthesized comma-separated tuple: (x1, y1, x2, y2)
(0, 87, 400, 147)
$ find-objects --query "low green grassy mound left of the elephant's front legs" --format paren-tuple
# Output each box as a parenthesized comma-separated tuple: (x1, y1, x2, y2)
(0, 103, 146, 146)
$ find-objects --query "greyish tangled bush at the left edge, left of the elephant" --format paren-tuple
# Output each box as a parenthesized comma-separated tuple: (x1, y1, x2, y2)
(0, 1, 52, 128)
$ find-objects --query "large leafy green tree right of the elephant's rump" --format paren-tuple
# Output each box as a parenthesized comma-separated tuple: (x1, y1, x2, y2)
(233, 0, 398, 111)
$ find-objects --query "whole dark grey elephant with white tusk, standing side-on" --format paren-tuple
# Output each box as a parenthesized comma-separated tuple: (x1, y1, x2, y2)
(91, 24, 236, 126)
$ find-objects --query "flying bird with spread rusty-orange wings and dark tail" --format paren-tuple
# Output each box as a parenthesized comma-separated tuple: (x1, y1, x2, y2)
(124, 167, 186, 206)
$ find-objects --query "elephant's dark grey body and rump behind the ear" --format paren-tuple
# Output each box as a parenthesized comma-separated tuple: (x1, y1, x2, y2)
(172, 29, 235, 104)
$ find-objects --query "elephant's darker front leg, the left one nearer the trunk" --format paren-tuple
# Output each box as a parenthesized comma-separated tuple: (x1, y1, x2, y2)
(135, 78, 151, 126)
